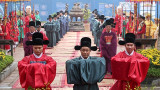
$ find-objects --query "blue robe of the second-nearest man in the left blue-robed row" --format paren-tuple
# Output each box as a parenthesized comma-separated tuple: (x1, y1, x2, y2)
(52, 20, 60, 43)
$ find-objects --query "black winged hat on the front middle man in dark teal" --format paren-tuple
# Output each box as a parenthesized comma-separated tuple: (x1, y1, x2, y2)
(74, 37, 97, 51)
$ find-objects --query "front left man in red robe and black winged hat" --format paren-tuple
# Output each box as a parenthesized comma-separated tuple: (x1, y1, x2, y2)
(18, 32, 56, 90)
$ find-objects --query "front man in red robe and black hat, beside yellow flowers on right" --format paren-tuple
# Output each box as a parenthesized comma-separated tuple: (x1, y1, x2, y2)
(110, 33, 150, 90)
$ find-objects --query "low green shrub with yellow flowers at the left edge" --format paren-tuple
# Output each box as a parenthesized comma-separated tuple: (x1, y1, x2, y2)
(0, 55, 14, 72)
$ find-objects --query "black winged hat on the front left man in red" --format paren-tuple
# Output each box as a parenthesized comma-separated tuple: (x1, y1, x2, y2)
(26, 32, 49, 45)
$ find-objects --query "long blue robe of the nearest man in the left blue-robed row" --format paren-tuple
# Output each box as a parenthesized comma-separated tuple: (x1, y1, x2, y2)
(44, 22, 56, 47)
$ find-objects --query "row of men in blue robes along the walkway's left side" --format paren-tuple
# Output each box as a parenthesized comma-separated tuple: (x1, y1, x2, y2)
(42, 12, 69, 47)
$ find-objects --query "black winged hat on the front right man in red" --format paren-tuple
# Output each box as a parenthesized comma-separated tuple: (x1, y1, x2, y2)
(118, 33, 141, 46)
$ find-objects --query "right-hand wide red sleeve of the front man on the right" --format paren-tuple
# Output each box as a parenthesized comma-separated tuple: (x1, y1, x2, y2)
(128, 55, 150, 83)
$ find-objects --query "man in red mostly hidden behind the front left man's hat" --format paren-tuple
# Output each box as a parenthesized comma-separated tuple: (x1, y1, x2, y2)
(36, 21, 48, 54)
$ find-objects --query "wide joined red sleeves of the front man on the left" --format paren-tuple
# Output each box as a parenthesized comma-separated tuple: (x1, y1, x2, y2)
(18, 58, 56, 88)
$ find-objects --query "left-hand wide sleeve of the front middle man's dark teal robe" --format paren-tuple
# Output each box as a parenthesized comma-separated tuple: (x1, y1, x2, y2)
(66, 60, 81, 84)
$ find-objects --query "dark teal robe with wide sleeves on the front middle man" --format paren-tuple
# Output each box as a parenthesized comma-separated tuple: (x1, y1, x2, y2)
(66, 57, 106, 90)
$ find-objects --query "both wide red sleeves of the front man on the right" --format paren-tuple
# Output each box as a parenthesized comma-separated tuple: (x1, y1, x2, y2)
(111, 53, 150, 83)
